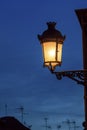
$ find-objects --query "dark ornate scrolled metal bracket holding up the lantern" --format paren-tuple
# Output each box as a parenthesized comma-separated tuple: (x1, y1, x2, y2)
(53, 70, 87, 85)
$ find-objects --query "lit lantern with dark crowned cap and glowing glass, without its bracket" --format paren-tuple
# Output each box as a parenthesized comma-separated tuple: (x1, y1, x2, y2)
(38, 22, 65, 71)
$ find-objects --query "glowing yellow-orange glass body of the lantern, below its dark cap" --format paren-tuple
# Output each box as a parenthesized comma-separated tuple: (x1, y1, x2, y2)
(42, 42, 62, 67)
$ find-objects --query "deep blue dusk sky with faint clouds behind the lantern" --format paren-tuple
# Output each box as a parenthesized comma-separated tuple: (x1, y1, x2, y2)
(0, 0, 87, 130)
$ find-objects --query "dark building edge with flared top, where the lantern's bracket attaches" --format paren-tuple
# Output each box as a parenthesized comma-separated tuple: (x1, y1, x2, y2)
(76, 9, 87, 130)
